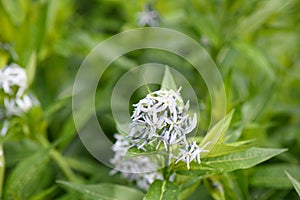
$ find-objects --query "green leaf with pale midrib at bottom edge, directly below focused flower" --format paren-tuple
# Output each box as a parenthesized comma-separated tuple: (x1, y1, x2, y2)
(144, 180, 179, 200)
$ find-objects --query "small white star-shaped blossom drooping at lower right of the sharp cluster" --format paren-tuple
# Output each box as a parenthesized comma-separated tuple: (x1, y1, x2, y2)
(175, 142, 209, 169)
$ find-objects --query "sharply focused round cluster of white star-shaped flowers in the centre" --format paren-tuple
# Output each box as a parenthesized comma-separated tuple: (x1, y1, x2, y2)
(129, 89, 197, 150)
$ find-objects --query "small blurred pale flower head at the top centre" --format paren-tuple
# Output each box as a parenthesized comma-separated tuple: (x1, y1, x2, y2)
(137, 5, 159, 27)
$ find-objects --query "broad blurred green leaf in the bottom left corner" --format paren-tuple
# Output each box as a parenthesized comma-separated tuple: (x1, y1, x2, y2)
(5, 146, 51, 199)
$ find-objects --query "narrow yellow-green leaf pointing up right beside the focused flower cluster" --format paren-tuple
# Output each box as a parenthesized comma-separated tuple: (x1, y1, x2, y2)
(200, 111, 234, 158)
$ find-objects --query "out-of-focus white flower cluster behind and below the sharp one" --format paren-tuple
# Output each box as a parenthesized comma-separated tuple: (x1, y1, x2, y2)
(110, 134, 162, 190)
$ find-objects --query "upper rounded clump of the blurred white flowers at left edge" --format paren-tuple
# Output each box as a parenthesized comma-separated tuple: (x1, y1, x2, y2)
(0, 63, 27, 97)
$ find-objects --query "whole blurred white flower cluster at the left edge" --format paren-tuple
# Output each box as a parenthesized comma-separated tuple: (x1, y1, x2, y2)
(0, 63, 37, 136)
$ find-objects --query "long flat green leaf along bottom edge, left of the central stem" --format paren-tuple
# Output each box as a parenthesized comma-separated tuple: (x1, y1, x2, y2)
(57, 181, 144, 200)
